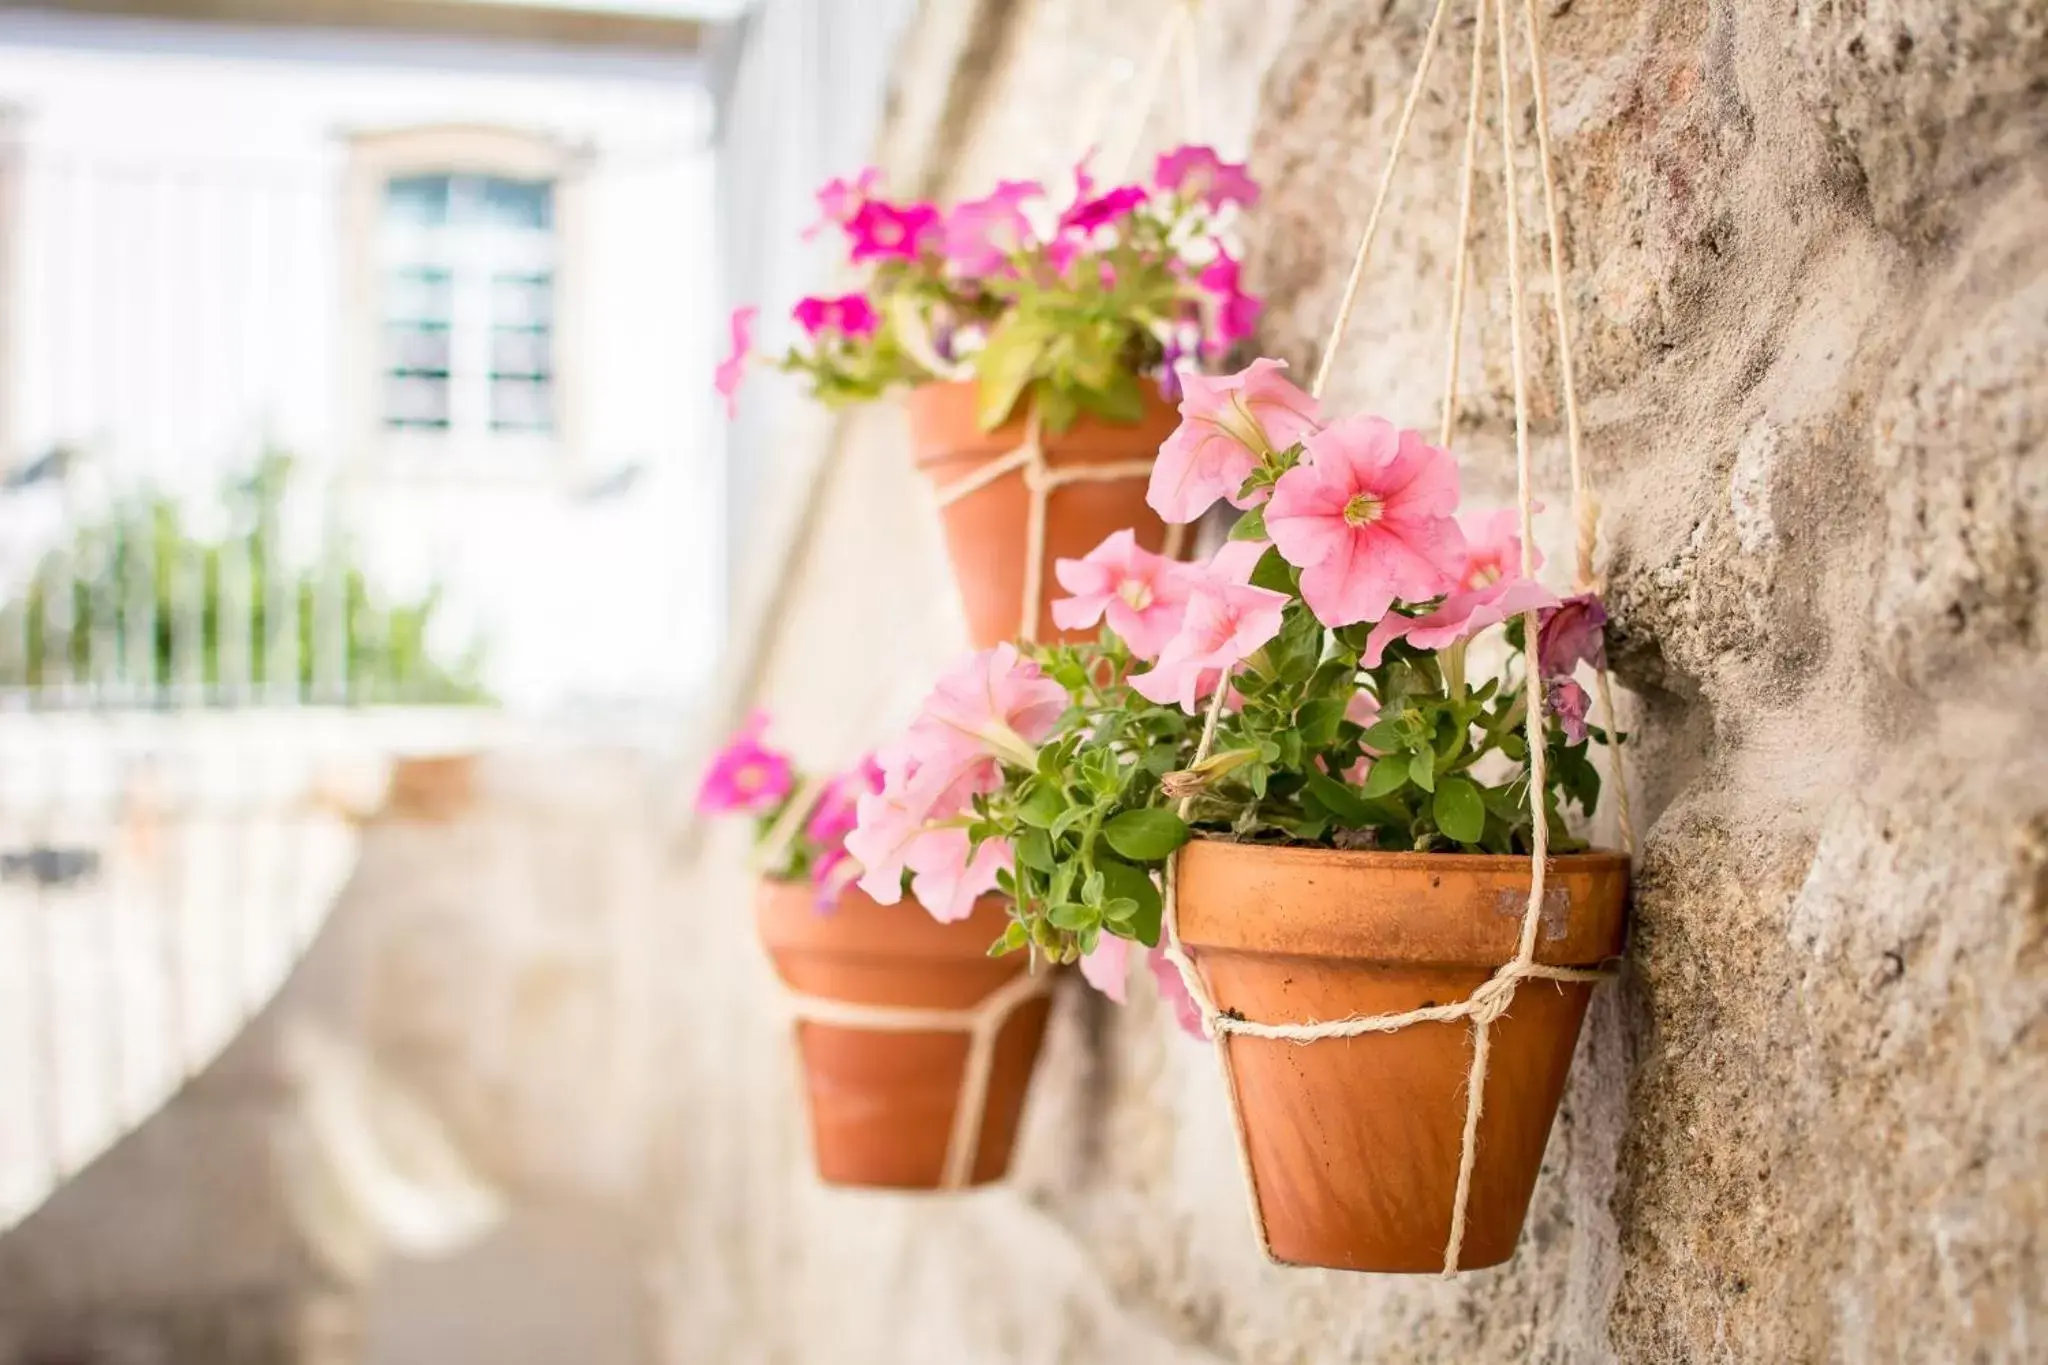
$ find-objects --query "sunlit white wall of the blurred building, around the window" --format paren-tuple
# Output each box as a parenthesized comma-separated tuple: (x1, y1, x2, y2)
(0, 14, 719, 720)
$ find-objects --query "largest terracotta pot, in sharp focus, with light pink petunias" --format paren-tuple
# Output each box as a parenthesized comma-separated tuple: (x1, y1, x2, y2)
(1176, 839, 1628, 1271)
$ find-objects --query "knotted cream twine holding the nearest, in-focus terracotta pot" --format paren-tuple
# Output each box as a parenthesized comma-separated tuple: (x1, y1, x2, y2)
(1161, 0, 1634, 1277)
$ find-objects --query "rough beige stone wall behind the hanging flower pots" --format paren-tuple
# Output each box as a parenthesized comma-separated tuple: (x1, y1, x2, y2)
(662, 0, 2048, 1365)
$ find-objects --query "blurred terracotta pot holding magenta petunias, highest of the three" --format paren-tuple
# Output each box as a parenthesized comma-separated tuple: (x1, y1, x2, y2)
(905, 381, 1180, 649)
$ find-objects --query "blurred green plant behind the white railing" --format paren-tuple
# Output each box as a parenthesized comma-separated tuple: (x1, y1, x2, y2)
(0, 452, 492, 706)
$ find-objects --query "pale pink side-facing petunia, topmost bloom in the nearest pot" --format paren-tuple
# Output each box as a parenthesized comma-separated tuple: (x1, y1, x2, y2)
(1145, 358, 1321, 522)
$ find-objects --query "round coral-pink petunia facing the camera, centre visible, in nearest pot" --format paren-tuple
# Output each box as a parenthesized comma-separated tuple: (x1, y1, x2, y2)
(1266, 417, 1464, 626)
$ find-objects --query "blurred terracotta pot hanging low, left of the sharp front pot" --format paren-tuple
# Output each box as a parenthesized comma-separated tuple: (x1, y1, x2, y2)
(758, 880, 1051, 1189)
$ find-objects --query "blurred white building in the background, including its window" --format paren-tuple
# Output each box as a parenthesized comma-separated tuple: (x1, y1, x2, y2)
(0, 4, 723, 708)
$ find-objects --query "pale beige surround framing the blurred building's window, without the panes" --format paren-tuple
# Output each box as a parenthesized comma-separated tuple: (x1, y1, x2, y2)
(340, 125, 590, 483)
